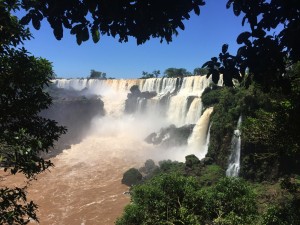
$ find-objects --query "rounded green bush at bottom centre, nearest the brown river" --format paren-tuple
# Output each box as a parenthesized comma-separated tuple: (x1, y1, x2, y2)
(116, 173, 200, 225)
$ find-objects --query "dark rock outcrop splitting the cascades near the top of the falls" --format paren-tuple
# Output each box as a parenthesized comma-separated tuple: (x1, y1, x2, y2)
(125, 85, 157, 114)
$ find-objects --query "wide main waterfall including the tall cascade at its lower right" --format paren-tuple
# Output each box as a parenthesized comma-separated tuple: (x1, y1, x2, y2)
(53, 76, 213, 161)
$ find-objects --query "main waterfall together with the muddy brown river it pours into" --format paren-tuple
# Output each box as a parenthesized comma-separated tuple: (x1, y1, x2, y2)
(28, 77, 212, 225)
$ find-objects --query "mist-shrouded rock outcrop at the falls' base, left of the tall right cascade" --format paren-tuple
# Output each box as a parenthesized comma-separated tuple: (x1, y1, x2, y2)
(145, 124, 195, 147)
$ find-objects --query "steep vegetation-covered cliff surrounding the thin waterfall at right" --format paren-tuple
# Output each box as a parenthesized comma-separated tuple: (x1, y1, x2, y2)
(202, 79, 300, 181)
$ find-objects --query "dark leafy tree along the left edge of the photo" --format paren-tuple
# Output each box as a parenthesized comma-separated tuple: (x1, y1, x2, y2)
(0, 1, 65, 224)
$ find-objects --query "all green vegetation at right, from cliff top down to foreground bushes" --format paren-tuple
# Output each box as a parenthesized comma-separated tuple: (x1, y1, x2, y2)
(116, 59, 300, 225)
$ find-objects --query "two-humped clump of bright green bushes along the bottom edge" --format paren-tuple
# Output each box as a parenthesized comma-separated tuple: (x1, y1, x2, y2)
(116, 176, 257, 225)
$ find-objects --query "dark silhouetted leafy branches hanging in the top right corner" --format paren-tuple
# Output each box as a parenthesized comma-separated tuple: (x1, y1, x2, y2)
(203, 0, 300, 92)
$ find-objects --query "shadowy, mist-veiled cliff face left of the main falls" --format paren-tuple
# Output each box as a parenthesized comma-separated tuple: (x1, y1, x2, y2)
(40, 87, 104, 157)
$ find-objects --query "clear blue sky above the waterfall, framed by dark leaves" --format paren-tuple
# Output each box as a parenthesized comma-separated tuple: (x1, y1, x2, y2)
(18, 0, 246, 78)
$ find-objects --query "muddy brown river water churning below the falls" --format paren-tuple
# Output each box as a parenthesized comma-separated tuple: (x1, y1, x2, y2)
(1, 132, 156, 225)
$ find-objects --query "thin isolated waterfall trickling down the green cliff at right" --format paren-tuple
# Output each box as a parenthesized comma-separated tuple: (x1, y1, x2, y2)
(226, 116, 242, 177)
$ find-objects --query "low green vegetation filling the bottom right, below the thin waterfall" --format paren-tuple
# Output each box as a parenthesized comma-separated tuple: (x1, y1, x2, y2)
(116, 155, 300, 225)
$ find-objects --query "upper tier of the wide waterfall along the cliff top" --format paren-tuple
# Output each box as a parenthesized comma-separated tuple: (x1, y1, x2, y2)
(53, 76, 211, 126)
